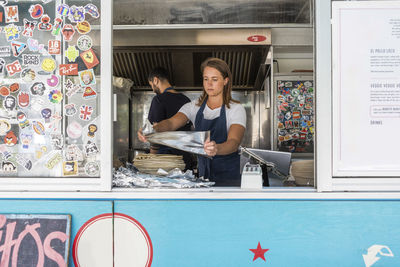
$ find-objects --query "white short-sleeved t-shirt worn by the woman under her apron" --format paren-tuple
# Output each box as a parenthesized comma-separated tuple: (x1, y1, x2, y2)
(178, 99, 246, 131)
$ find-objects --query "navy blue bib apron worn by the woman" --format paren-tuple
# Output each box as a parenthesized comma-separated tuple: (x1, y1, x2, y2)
(195, 99, 240, 186)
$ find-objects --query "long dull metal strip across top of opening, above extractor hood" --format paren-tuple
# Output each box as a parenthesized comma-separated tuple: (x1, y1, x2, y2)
(114, 0, 313, 25)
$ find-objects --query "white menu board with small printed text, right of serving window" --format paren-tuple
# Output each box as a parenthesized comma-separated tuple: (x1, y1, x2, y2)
(332, 1, 400, 177)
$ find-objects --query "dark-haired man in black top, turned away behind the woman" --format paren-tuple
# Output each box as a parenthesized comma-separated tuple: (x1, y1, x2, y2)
(138, 67, 196, 169)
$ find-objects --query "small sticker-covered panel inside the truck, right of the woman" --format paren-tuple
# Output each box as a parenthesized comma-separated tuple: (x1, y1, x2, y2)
(272, 73, 315, 156)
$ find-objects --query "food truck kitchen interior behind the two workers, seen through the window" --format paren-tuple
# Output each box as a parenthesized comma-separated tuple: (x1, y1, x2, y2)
(113, 0, 315, 188)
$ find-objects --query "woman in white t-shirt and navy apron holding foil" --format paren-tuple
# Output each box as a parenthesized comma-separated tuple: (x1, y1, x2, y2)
(141, 58, 246, 186)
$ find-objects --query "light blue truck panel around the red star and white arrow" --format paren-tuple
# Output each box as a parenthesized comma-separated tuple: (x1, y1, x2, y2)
(114, 200, 400, 267)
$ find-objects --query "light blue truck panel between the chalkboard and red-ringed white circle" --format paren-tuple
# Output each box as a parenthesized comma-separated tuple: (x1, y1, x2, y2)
(0, 200, 113, 266)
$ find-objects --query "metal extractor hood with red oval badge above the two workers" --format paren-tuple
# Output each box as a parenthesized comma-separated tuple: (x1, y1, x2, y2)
(113, 28, 271, 90)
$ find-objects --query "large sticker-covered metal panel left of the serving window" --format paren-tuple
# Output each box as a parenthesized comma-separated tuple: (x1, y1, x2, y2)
(0, 0, 112, 190)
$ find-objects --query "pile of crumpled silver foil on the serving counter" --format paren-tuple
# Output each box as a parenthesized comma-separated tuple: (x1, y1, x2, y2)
(113, 163, 215, 188)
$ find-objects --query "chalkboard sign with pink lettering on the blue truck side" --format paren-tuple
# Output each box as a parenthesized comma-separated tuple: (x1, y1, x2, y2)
(0, 214, 71, 267)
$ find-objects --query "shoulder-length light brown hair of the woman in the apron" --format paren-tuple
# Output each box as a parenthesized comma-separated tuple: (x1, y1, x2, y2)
(197, 57, 240, 108)
